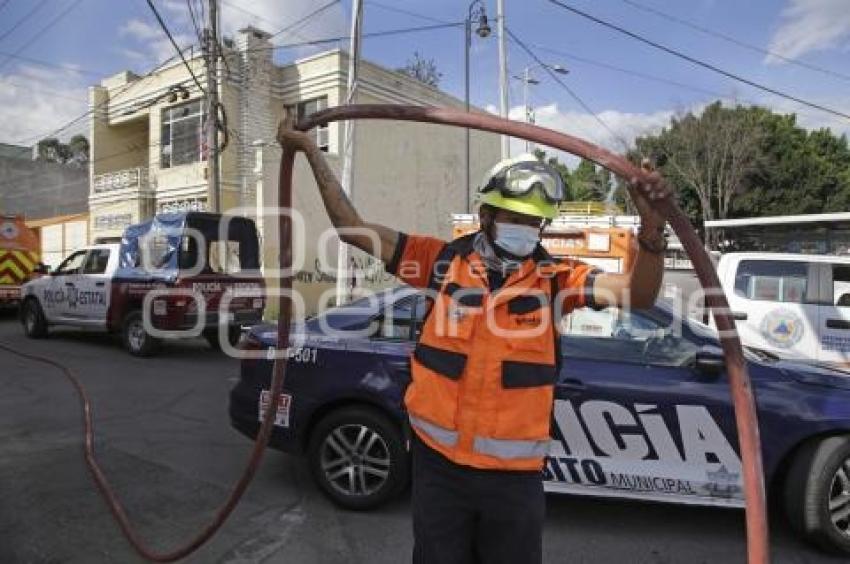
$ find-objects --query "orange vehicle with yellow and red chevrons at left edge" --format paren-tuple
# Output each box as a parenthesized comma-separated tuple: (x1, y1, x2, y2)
(0, 215, 40, 307)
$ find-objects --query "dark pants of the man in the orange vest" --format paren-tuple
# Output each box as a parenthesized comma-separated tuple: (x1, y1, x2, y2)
(412, 433, 546, 564)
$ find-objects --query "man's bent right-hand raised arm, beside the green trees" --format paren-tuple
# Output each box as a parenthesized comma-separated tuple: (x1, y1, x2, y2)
(593, 173, 671, 309)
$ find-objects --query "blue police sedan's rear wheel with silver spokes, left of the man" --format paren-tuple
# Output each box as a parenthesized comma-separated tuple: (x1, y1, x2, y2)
(307, 406, 410, 510)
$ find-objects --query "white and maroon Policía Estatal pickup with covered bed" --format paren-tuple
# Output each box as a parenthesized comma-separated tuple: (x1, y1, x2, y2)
(21, 212, 265, 356)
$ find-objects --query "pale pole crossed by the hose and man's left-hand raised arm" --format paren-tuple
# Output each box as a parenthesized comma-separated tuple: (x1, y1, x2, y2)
(336, 0, 363, 305)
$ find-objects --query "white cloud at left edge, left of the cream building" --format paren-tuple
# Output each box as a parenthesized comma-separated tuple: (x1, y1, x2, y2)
(0, 65, 88, 145)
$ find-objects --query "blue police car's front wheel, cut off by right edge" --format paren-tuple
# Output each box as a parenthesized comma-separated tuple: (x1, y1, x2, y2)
(785, 436, 850, 554)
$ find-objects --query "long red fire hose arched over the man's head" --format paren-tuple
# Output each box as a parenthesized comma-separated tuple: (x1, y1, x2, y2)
(0, 105, 769, 564)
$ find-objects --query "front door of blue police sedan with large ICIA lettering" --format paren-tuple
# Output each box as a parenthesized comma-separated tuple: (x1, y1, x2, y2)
(545, 311, 741, 505)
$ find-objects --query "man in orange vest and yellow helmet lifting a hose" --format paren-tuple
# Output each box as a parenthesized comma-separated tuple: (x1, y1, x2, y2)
(278, 120, 669, 564)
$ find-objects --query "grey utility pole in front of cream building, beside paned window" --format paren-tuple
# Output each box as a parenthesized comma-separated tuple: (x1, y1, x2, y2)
(204, 0, 221, 213)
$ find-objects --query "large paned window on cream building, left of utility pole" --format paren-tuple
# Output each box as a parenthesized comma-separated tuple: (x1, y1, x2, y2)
(159, 100, 206, 168)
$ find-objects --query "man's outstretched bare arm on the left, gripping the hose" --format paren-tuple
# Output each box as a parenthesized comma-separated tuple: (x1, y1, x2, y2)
(278, 115, 399, 263)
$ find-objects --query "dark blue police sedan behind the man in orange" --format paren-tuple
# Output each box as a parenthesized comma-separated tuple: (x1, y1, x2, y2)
(230, 287, 850, 553)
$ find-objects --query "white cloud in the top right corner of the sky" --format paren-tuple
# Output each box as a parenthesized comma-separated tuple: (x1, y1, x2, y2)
(765, 0, 850, 64)
